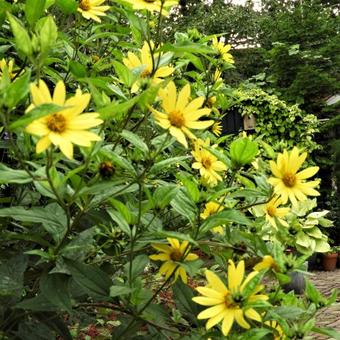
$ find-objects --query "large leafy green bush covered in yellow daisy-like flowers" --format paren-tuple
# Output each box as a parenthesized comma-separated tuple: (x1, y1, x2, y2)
(0, 0, 334, 339)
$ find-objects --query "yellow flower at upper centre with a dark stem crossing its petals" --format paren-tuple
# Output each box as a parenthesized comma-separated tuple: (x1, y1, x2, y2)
(123, 41, 175, 93)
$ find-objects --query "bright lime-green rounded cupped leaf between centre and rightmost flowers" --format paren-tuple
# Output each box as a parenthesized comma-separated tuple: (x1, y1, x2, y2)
(230, 137, 258, 167)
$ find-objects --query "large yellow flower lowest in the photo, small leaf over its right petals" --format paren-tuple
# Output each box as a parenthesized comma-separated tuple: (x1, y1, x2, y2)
(192, 260, 268, 336)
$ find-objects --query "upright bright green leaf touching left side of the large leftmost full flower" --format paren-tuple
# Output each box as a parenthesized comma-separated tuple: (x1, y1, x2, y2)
(4, 70, 31, 109)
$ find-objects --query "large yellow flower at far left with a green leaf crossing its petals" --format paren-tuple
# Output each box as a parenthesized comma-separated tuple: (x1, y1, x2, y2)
(25, 80, 103, 159)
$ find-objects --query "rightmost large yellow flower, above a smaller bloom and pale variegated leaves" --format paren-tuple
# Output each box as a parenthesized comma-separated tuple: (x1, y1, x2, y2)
(268, 147, 319, 205)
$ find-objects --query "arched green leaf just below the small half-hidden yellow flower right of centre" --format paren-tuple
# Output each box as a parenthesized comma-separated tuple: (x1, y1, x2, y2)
(200, 209, 252, 233)
